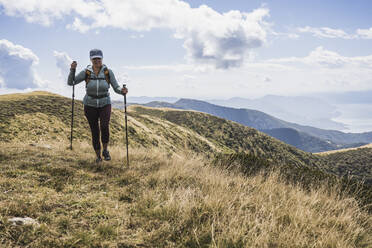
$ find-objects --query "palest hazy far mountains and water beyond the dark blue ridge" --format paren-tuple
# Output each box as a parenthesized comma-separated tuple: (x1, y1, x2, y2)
(115, 91, 372, 133)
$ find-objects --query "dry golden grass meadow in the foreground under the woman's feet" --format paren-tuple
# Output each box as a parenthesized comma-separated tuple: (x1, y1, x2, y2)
(0, 142, 372, 247)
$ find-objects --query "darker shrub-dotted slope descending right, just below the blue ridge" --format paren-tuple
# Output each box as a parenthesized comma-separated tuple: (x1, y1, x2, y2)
(132, 106, 320, 166)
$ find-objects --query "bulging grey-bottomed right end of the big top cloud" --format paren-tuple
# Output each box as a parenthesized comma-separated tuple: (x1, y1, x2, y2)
(177, 6, 268, 68)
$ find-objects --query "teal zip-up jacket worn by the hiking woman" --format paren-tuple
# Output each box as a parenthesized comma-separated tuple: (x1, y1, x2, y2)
(67, 65, 123, 108)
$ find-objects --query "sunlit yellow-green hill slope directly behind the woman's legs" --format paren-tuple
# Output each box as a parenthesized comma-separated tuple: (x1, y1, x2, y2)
(0, 92, 226, 155)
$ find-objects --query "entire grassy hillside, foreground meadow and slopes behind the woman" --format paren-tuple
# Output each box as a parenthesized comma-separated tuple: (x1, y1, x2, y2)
(0, 92, 372, 247)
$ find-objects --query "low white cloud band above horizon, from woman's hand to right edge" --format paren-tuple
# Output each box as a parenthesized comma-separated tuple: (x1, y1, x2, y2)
(117, 47, 372, 99)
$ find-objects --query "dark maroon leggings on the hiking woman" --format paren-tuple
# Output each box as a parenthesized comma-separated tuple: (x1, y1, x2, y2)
(84, 104, 111, 150)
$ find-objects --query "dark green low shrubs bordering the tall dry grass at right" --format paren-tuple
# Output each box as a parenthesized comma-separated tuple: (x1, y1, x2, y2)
(212, 153, 372, 213)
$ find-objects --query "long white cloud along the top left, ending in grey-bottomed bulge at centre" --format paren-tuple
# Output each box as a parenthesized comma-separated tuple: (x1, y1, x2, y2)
(0, 0, 269, 68)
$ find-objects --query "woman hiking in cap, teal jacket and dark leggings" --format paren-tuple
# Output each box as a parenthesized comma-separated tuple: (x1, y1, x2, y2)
(67, 49, 128, 163)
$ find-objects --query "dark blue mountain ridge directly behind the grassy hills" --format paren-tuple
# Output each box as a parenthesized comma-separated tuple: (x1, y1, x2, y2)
(138, 99, 372, 152)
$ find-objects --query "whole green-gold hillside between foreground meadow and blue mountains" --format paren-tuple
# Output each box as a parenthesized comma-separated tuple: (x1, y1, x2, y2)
(0, 92, 372, 184)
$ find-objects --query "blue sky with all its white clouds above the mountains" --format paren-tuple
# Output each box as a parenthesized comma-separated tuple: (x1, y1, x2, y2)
(0, 0, 372, 130)
